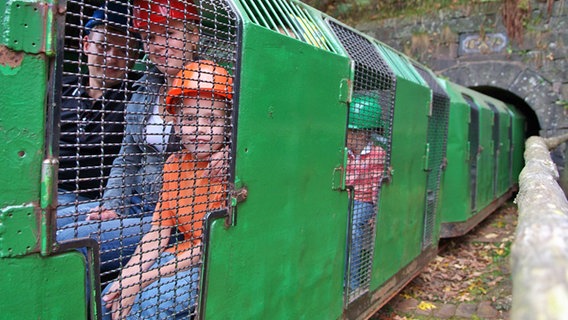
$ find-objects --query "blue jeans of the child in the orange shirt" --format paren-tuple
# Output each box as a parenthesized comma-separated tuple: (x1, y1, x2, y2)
(101, 252, 199, 320)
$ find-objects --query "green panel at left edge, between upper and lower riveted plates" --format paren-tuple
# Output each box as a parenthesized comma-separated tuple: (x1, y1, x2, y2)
(0, 55, 47, 206)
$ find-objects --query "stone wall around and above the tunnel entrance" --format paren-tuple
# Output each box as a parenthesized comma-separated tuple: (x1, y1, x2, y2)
(356, 0, 568, 171)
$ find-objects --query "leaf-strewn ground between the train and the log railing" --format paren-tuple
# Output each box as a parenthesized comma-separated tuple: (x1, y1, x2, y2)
(371, 202, 517, 320)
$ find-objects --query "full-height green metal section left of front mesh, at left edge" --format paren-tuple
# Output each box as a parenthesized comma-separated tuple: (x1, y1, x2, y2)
(0, 1, 87, 319)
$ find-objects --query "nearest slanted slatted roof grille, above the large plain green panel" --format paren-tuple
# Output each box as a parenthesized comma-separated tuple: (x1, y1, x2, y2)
(241, 0, 336, 52)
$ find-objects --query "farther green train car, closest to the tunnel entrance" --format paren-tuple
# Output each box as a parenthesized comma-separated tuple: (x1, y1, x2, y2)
(438, 81, 526, 237)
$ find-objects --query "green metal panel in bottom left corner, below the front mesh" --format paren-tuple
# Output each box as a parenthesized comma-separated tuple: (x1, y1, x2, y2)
(0, 252, 87, 320)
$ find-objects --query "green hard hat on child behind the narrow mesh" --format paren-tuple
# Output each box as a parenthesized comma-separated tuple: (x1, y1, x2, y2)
(349, 92, 383, 129)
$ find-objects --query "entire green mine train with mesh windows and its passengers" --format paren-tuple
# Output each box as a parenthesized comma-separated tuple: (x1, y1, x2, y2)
(0, 0, 526, 320)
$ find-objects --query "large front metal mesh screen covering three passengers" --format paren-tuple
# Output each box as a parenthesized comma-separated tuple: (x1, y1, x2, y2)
(54, 0, 238, 319)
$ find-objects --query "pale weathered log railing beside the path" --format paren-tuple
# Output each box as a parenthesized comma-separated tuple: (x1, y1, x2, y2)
(511, 136, 568, 320)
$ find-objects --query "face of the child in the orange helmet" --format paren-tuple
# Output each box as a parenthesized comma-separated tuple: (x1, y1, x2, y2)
(175, 97, 227, 159)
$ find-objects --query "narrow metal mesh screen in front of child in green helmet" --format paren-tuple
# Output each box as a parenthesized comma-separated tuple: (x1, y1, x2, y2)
(329, 21, 396, 303)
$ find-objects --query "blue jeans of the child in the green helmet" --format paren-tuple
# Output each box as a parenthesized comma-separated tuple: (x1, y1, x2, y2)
(349, 200, 375, 291)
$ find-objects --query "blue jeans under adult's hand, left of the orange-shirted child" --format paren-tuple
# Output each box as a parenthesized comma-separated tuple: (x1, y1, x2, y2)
(57, 196, 154, 273)
